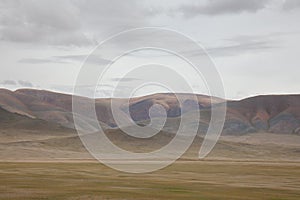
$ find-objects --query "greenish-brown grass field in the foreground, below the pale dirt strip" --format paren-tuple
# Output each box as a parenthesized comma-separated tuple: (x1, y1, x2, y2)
(0, 161, 300, 200)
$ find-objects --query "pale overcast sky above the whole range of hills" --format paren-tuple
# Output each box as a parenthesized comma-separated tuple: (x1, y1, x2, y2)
(0, 0, 300, 99)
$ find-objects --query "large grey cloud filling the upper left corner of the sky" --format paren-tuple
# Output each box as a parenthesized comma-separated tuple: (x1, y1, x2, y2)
(0, 0, 150, 46)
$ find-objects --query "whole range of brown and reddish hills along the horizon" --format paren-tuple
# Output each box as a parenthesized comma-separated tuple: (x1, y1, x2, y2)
(0, 89, 300, 135)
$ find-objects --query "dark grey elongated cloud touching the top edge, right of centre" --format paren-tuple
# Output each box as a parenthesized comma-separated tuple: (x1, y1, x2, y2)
(178, 0, 269, 17)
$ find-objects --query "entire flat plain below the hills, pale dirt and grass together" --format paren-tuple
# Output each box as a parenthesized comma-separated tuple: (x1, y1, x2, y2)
(0, 130, 300, 200)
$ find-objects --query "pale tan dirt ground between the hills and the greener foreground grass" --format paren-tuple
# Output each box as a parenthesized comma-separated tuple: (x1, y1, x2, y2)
(0, 130, 300, 162)
